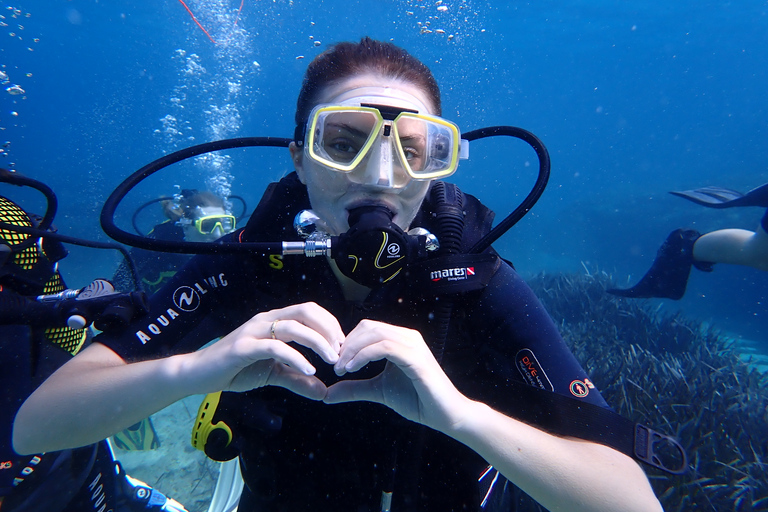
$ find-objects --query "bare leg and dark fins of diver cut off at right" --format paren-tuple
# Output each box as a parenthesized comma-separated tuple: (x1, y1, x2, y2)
(608, 183, 768, 300)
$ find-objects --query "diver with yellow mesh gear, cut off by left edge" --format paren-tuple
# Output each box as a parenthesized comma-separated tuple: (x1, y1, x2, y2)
(0, 174, 185, 512)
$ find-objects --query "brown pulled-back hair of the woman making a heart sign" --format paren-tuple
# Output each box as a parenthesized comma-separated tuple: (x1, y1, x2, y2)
(296, 37, 441, 137)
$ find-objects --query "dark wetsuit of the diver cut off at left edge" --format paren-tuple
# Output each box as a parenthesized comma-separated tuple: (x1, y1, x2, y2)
(0, 288, 156, 512)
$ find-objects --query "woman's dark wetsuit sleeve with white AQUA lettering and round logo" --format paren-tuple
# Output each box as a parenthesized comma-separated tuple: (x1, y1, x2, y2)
(95, 255, 248, 361)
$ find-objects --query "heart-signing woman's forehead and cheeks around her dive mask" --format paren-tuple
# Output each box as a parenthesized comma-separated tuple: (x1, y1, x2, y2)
(291, 74, 435, 235)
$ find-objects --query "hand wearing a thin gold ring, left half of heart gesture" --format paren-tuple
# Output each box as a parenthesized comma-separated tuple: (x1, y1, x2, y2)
(182, 302, 344, 400)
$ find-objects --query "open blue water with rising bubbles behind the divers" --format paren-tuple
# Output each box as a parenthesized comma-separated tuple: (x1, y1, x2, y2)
(0, 0, 768, 344)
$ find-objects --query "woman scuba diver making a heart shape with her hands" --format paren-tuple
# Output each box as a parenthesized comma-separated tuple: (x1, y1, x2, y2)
(13, 38, 661, 511)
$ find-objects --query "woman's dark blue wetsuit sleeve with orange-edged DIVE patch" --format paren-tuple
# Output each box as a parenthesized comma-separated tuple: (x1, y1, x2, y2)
(460, 263, 608, 410)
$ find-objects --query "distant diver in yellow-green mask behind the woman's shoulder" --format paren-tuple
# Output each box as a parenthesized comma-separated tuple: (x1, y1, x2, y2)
(112, 189, 237, 293)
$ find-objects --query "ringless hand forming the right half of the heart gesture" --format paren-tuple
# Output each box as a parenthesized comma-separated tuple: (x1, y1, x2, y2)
(323, 320, 470, 432)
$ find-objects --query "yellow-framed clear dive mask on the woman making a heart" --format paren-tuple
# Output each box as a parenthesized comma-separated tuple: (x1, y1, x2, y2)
(304, 97, 465, 188)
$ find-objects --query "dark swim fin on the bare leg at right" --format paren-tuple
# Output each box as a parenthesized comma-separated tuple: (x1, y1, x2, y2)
(606, 229, 713, 300)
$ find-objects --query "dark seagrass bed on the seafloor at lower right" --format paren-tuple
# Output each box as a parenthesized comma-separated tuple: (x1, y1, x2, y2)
(529, 273, 768, 512)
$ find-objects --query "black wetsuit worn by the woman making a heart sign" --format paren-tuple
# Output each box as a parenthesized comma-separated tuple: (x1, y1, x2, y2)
(97, 174, 607, 512)
